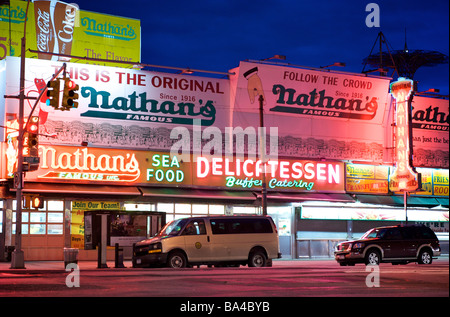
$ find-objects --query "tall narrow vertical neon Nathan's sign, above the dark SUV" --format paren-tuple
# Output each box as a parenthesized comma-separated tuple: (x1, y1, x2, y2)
(389, 78, 420, 191)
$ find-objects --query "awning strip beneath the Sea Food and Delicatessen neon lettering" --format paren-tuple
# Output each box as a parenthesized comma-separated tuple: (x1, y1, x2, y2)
(139, 187, 255, 201)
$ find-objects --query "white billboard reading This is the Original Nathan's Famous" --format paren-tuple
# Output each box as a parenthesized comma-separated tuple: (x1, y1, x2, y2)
(5, 57, 230, 150)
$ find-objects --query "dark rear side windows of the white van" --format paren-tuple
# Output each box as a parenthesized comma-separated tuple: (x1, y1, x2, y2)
(210, 218, 273, 234)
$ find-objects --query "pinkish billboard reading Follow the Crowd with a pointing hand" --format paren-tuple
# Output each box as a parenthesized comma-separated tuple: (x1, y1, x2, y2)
(230, 62, 389, 162)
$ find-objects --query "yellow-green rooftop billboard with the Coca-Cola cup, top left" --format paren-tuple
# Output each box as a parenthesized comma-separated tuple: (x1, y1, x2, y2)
(0, 0, 141, 66)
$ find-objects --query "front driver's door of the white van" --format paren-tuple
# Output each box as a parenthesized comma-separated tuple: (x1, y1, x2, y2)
(181, 219, 211, 262)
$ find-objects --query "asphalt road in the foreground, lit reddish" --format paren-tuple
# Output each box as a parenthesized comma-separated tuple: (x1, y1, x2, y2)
(0, 258, 449, 298)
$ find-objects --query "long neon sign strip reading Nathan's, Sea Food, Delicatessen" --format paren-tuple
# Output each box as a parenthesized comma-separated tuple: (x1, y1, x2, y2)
(14, 145, 345, 192)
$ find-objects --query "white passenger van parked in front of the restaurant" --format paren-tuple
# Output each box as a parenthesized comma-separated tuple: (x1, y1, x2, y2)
(133, 216, 281, 268)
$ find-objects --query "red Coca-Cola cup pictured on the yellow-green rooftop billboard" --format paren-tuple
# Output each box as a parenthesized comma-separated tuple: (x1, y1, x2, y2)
(34, 0, 78, 60)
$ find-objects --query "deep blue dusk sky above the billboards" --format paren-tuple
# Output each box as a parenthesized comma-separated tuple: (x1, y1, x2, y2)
(76, 0, 449, 95)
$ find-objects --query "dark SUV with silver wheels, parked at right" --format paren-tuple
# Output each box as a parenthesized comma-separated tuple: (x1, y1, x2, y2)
(334, 225, 441, 266)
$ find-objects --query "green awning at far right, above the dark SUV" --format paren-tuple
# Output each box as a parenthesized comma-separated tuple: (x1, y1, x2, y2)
(356, 195, 440, 207)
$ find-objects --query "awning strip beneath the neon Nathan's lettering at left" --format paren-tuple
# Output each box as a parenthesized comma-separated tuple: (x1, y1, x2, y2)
(17, 183, 141, 196)
